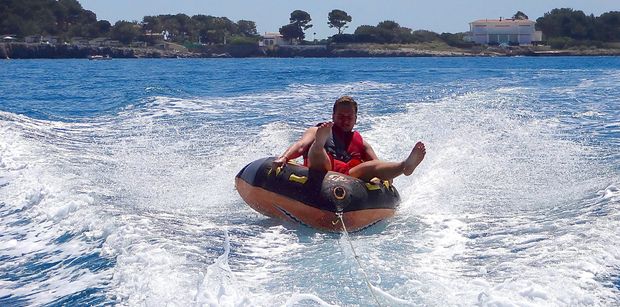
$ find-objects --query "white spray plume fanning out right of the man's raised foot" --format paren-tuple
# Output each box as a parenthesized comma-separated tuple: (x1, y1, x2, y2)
(365, 93, 612, 215)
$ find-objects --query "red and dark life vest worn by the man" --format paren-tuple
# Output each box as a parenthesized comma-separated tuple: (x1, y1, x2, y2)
(304, 127, 365, 175)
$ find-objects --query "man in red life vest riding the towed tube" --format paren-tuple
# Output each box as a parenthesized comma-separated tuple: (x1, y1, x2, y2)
(273, 96, 426, 181)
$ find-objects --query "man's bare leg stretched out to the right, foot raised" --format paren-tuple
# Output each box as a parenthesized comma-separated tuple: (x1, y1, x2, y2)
(349, 142, 426, 181)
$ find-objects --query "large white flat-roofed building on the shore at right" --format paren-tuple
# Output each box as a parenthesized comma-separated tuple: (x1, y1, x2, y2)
(469, 18, 542, 45)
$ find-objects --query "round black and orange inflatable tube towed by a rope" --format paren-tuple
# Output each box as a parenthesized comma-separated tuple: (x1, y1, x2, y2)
(235, 157, 400, 232)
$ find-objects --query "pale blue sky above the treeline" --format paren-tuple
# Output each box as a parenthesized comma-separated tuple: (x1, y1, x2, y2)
(79, 0, 620, 40)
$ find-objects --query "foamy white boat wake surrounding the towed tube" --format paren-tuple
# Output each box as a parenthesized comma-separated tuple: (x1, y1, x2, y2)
(0, 73, 620, 306)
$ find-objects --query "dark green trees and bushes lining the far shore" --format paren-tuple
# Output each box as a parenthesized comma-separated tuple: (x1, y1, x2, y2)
(0, 0, 620, 57)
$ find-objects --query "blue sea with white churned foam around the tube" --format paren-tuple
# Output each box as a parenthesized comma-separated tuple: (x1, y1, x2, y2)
(0, 57, 620, 306)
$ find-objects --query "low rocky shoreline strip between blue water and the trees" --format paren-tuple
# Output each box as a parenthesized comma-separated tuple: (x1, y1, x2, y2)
(0, 43, 620, 59)
